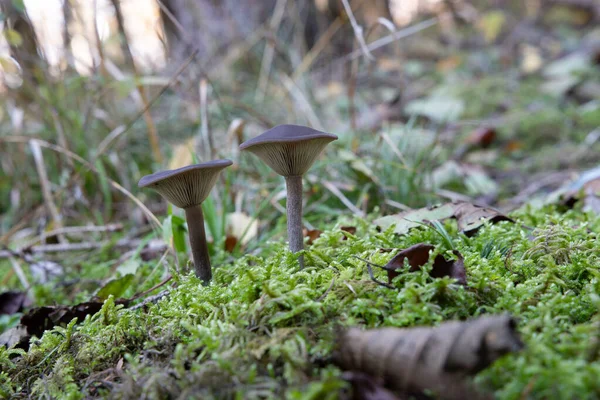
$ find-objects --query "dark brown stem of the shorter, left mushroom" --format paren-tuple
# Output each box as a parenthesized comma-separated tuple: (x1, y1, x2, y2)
(185, 205, 212, 284)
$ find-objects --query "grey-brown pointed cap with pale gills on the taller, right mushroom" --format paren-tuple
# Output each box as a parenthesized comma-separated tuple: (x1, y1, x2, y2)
(240, 125, 337, 176)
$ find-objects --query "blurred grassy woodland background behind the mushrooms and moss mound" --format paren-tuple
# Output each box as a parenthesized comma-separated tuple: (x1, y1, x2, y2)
(0, 0, 600, 304)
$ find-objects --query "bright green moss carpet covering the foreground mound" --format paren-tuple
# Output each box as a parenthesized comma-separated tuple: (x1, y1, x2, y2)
(0, 208, 600, 399)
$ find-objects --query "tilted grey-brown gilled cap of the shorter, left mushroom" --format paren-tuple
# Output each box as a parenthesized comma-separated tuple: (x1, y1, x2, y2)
(138, 160, 233, 208)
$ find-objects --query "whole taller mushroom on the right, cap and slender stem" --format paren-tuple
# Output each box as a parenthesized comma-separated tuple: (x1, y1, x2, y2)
(240, 125, 337, 268)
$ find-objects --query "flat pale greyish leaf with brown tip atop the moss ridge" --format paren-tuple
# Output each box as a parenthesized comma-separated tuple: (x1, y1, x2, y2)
(373, 201, 514, 236)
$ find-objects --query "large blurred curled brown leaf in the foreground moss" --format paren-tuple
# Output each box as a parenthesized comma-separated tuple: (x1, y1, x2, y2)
(334, 315, 523, 399)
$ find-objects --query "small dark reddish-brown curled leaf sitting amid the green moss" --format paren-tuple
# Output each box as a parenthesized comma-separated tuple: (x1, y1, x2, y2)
(383, 243, 467, 285)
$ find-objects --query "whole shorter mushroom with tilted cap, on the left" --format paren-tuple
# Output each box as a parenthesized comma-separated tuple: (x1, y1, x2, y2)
(138, 160, 232, 284)
